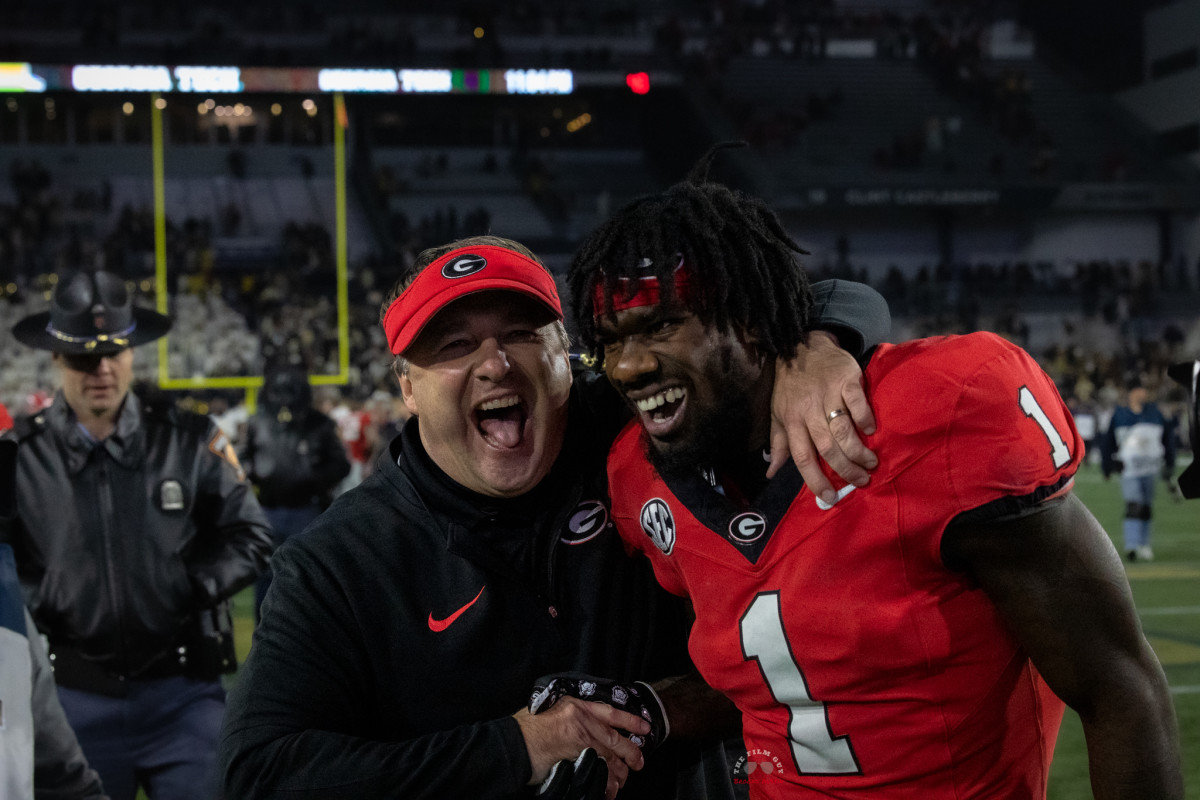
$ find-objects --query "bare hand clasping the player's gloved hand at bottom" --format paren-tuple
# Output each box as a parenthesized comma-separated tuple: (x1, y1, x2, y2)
(512, 697, 650, 800)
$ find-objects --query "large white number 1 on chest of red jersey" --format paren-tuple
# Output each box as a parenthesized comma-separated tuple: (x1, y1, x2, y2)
(740, 591, 859, 775)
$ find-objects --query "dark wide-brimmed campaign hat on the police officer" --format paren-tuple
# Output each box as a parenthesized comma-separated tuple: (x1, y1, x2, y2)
(12, 271, 172, 355)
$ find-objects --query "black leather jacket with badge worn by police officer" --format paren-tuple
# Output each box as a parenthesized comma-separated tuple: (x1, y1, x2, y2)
(0, 392, 271, 688)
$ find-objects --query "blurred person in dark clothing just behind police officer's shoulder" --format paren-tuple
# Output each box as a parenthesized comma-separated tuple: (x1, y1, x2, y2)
(239, 362, 350, 622)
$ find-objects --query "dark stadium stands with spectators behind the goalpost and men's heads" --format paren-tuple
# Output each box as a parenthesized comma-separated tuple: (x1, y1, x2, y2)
(0, 0, 1200, 438)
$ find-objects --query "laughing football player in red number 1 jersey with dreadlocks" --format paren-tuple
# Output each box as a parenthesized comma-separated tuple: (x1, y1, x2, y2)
(569, 145, 1183, 800)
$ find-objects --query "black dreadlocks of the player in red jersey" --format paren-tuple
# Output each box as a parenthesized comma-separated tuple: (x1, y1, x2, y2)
(568, 143, 812, 357)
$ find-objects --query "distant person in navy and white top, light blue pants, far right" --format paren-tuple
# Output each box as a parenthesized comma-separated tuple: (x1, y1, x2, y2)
(1100, 378, 1176, 561)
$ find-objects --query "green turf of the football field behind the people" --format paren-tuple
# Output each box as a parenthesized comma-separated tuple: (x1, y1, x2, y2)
(230, 455, 1200, 800)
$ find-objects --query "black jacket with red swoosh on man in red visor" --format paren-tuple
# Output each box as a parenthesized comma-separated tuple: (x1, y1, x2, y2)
(221, 379, 728, 800)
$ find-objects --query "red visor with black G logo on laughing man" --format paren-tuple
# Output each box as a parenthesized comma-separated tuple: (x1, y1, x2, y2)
(383, 245, 563, 354)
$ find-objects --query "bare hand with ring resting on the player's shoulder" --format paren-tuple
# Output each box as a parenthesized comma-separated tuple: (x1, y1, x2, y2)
(767, 331, 880, 505)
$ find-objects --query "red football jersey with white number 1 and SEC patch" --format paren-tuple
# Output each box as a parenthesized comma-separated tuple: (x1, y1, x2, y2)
(608, 333, 1084, 800)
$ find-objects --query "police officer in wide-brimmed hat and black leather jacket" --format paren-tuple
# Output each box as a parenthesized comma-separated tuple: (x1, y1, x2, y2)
(0, 271, 271, 800)
